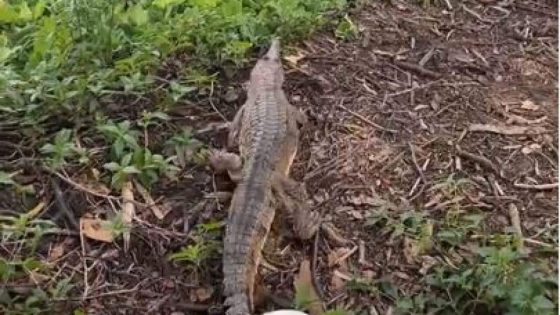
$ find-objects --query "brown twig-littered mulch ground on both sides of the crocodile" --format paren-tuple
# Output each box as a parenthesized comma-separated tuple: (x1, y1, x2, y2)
(15, 0, 558, 314)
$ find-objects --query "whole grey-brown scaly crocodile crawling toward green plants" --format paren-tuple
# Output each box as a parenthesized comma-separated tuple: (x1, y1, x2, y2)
(210, 38, 319, 315)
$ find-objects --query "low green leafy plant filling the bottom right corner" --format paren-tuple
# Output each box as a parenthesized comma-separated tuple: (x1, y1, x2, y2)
(397, 246, 558, 315)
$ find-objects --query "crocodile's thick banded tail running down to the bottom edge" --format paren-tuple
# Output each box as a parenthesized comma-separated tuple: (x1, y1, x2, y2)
(223, 180, 274, 315)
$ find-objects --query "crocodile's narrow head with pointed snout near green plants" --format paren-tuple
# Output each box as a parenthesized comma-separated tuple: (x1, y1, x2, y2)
(251, 38, 284, 86)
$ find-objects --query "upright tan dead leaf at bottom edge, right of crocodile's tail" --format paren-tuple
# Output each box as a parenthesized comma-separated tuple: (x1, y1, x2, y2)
(294, 259, 323, 315)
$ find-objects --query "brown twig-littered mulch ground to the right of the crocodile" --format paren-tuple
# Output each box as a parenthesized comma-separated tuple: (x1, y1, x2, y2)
(288, 1, 558, 313)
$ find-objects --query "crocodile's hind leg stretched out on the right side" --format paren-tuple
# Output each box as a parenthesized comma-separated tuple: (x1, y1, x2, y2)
(272, 173, 321, 240)
